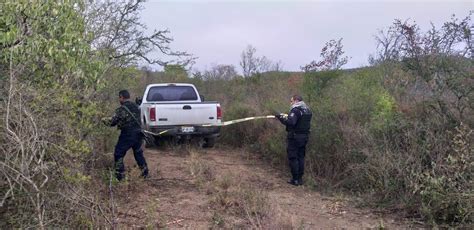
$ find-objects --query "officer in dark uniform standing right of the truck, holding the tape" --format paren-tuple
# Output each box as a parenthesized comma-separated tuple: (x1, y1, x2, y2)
(275, 95, 312, 186)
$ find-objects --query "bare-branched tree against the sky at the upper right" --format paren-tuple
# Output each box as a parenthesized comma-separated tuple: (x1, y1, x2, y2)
(374, 11, 473, 122)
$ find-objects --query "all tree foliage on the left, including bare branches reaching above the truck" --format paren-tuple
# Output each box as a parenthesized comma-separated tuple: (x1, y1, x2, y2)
(0, 0, 193, 229)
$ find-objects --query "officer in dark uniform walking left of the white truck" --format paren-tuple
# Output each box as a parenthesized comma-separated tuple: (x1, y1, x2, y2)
(104, 90, 148, 180)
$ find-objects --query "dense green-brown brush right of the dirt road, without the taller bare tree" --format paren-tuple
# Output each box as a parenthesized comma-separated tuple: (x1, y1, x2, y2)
(194, 63, 473, 224)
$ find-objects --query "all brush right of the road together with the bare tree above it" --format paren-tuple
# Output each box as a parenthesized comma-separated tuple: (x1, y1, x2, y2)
(190, 15, 474, 225)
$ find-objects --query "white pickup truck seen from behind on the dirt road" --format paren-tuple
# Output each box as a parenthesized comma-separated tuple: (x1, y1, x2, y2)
(140, 83, 222, 148)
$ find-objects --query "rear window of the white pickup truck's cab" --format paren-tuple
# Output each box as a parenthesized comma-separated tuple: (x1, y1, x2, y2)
(146, 85, 197, 101)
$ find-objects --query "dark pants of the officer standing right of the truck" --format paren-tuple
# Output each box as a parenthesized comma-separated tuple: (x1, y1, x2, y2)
(287, 135, 308, 180)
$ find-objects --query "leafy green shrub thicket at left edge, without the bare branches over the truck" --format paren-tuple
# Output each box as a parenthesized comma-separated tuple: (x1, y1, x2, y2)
(0, 1, 112, 228)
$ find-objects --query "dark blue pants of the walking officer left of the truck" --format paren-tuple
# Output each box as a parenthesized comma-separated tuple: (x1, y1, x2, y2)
(114, 130, 148, 180)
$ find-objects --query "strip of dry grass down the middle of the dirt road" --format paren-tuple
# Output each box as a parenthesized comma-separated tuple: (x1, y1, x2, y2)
(188, 150, 272, 229)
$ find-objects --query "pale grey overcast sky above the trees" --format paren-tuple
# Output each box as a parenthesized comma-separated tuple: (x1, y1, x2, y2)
(141, 0, 474, 71)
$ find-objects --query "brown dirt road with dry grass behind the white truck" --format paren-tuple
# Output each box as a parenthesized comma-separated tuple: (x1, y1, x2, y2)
(115, 147, 409, 229)
